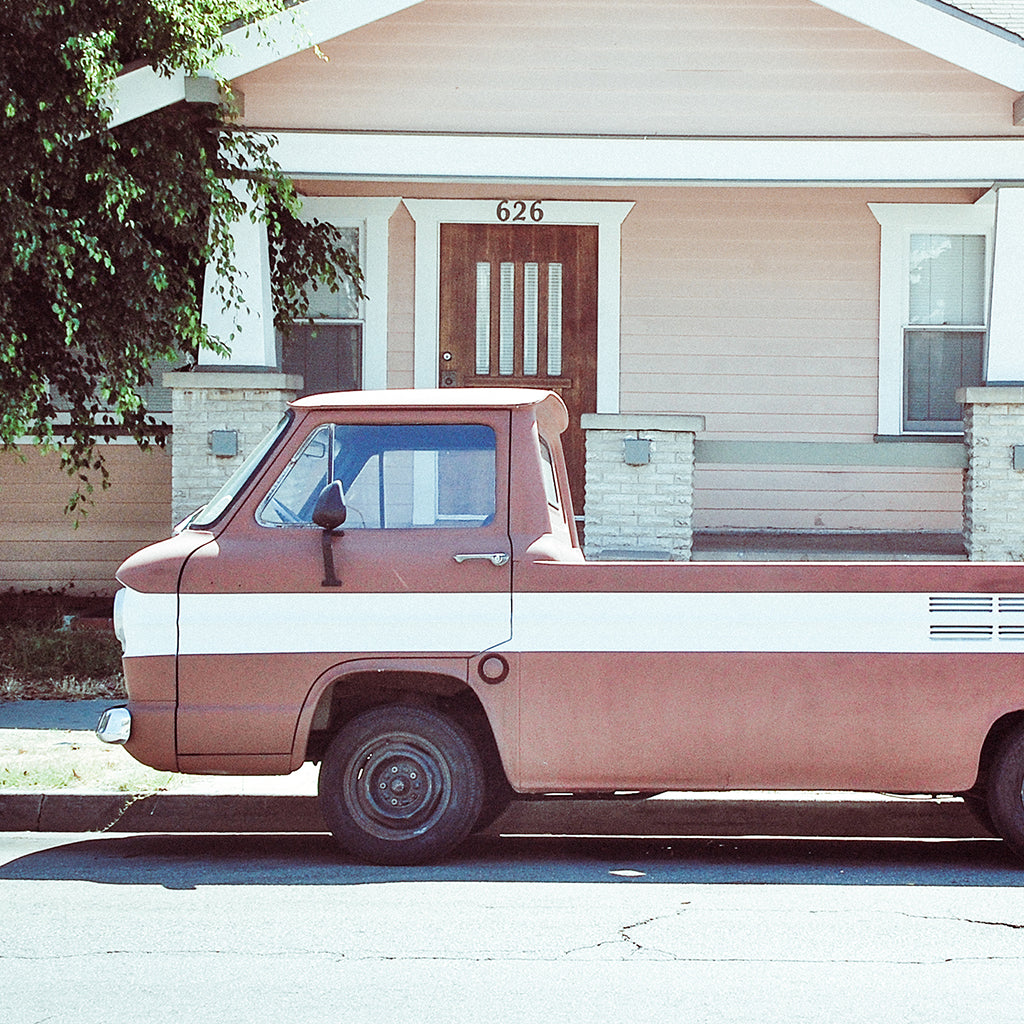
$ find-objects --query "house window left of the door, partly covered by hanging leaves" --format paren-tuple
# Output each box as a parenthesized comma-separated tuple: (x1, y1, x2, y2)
(281, 226, 365, 395)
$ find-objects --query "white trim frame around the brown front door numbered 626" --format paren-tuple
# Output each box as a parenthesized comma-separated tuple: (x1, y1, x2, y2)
(404, 199, 633, 413)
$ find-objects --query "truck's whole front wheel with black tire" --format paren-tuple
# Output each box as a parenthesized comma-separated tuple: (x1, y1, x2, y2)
(319, 705, 484, 864)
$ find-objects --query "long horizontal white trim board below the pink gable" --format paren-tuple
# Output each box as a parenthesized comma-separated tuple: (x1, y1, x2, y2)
(269, 131, 1024, 187)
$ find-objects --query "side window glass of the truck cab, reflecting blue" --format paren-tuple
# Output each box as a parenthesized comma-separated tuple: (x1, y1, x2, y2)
(256, 424, 496, 529)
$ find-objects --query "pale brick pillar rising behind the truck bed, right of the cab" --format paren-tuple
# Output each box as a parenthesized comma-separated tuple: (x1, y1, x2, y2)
(582, 413, 705, 561)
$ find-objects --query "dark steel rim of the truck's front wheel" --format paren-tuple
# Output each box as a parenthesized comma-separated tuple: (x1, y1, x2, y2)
(342, 732, 452, 840)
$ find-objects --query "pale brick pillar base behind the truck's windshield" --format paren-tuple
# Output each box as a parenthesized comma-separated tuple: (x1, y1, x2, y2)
(164, 371, 302, 522)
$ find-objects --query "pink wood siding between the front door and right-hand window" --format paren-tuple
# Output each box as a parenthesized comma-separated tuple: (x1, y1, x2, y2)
(621, 188, 937, 441)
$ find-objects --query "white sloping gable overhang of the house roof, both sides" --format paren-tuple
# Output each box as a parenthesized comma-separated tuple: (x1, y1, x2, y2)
(112, 0, 1024, 125)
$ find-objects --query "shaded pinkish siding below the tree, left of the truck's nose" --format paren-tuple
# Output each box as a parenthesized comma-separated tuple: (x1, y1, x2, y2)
(0, 444, 171, 595)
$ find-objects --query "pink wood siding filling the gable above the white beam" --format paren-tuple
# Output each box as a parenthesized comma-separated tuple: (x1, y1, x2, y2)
(238, 0, 1024, 136)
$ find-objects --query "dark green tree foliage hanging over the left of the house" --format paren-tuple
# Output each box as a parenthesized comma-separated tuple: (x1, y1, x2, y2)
(0, 0, 358, 508)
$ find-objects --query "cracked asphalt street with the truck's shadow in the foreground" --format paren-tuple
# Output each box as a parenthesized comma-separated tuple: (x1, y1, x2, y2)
(0, 834, 1024, 1024)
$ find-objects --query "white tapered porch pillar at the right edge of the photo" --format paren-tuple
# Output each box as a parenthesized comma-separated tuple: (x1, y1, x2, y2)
(985, 186, 1024, 385)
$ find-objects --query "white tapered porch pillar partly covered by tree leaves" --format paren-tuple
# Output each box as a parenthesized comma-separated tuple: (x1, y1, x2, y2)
(199, 187, 278, 370)
